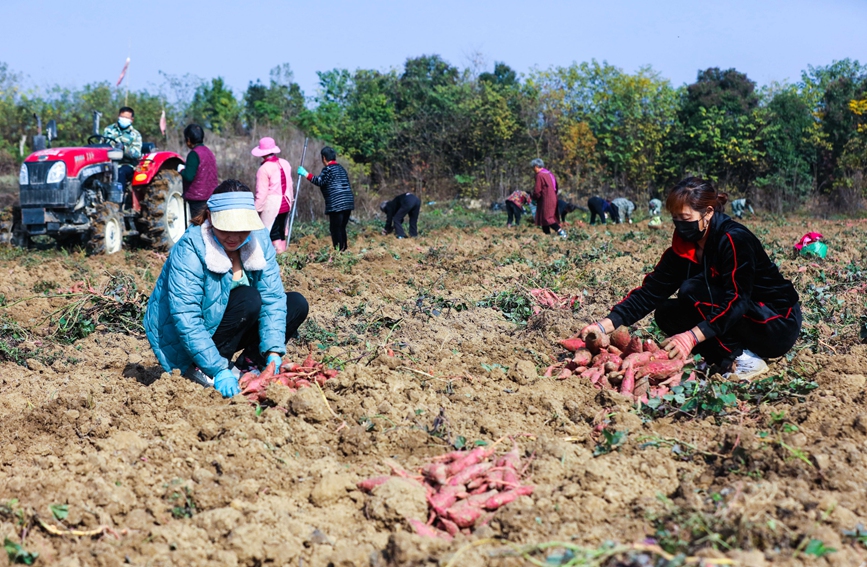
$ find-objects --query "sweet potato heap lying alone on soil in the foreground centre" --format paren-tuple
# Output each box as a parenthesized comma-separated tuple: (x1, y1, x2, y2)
(358, 441, 535, 540)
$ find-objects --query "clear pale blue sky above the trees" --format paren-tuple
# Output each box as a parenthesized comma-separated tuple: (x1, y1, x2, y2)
(0, 0, 867, 101)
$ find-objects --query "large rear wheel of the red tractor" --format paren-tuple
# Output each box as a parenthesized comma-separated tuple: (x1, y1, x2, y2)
(138, 169, 187, 251)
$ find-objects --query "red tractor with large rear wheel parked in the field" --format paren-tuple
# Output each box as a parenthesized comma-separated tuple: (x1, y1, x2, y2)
(11, 123, 187, 254)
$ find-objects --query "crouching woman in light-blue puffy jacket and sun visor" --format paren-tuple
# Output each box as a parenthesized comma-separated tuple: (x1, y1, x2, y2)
(144, 179, 308, 397)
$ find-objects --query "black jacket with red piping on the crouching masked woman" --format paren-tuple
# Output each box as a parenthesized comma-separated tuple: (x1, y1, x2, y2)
(608, 212, 798, 339)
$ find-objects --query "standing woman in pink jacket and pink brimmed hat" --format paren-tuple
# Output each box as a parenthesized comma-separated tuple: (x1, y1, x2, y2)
(250, 138, 295, 254)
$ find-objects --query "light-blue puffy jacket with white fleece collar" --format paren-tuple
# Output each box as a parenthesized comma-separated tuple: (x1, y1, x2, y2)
(144, 222, 286, 377)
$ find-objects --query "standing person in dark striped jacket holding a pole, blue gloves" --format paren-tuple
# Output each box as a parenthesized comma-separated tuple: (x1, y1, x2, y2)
(298, 146, 355, 252)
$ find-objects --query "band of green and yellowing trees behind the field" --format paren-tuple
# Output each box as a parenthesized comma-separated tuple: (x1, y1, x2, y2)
(0, 55, 867, 212)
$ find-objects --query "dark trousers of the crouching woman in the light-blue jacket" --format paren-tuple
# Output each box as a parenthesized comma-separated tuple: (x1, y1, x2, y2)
(212, 285, 309, 366)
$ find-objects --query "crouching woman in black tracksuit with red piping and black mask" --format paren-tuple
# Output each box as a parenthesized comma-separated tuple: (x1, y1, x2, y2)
(582, 177, 801, 379)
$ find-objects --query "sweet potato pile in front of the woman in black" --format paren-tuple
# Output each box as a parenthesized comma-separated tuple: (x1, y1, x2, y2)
(545, 327, 695, 402)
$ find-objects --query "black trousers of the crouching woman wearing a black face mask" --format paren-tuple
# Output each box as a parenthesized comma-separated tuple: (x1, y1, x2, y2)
(654, 276, 801, 369)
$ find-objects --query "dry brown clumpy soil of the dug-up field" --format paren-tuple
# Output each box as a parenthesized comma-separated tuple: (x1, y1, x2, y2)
(0, 215, 867, 567)
